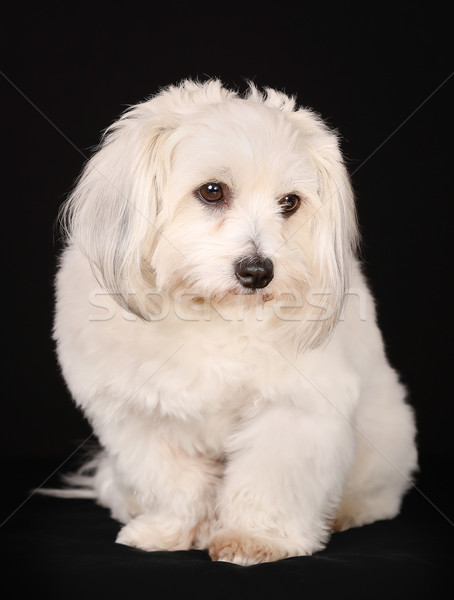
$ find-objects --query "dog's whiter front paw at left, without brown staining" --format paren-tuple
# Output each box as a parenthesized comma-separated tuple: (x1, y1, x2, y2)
(116, 515, 194, 552)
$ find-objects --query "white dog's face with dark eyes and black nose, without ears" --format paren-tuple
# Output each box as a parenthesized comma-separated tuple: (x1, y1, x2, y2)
(156, 100, 318, 300)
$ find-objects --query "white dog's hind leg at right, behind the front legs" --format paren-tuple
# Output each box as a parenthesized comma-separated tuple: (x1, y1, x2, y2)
(333, 366, 417, 531)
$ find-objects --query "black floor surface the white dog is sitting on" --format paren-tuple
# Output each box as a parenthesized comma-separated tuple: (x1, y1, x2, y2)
(0, 457, 454, 600)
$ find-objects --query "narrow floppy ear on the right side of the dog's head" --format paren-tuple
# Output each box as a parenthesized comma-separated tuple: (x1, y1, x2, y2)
(292, 109, 358, 348)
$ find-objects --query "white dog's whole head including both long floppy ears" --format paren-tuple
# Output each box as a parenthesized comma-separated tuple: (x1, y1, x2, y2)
(64, 81, 357, 346)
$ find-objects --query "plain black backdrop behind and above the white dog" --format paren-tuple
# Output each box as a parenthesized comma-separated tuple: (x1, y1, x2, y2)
(0, 1, 454, 596)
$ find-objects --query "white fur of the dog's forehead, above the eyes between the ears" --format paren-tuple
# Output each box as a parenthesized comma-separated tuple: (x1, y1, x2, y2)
(169, 98, 316, 197)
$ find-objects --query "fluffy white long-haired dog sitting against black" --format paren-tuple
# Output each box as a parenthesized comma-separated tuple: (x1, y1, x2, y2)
(54, 81, 417, 565)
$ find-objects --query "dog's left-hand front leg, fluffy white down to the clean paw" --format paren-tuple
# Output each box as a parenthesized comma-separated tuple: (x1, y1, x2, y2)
(105, 424, 221, 551)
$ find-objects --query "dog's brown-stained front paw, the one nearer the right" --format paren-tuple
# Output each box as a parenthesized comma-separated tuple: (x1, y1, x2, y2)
(208, 531, 306, 566)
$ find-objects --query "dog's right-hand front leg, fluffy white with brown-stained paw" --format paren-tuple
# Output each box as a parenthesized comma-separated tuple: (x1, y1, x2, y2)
(209, 398, 354, 565)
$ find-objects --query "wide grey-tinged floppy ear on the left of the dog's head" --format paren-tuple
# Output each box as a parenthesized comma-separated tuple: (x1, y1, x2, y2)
(61, 95, 179, 318)
